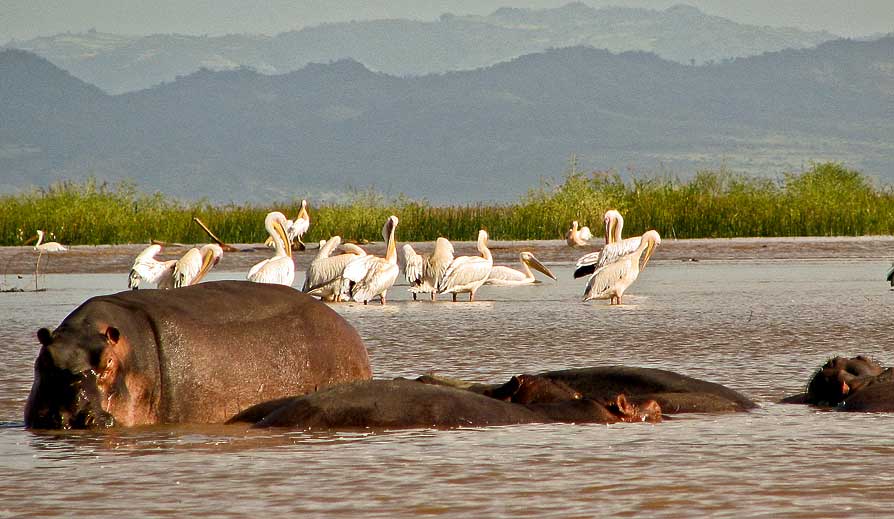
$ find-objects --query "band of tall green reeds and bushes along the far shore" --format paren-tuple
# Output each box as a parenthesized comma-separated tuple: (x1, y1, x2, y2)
(0, 163, 894, 245)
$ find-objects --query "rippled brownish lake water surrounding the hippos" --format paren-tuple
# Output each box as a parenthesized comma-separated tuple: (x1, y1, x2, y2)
(0, 249, 894, 518)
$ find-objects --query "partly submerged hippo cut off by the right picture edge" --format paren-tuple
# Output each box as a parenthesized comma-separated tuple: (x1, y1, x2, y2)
(781, 355, 894, 412)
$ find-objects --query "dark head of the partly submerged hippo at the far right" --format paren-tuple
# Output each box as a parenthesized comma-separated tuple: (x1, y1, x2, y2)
(807, 355, 884, 406)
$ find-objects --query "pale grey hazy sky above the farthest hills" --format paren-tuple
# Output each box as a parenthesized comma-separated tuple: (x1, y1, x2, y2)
(0, 0, 894, 42)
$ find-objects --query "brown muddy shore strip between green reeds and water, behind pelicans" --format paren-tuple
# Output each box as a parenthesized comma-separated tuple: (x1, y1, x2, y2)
(0, 236, 894, 276)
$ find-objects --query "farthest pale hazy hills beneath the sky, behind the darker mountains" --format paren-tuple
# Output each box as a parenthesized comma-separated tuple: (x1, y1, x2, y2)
(9, 3, 835, 93)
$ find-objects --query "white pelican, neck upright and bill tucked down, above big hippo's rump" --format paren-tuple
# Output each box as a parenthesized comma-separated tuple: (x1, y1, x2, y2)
(342, 215, 400, 305)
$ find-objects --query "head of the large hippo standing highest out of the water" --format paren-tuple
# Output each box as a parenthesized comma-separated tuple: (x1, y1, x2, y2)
(25, 316, 158, 429)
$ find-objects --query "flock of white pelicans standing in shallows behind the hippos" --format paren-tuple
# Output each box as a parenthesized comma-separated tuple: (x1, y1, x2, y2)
(119, 200, 661, 305)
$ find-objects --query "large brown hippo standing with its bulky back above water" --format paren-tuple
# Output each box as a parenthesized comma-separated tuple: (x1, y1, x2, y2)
(25, 281, 372, 429)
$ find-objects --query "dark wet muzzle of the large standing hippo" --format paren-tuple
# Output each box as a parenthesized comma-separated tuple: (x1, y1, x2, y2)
(25, 369, 115, 429)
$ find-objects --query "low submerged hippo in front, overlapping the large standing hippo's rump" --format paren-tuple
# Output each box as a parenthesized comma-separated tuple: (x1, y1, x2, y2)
(227, 378, 661, 430)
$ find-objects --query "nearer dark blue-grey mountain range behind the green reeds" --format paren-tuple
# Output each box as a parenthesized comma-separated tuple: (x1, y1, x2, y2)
(0, 37, 894, 202)
